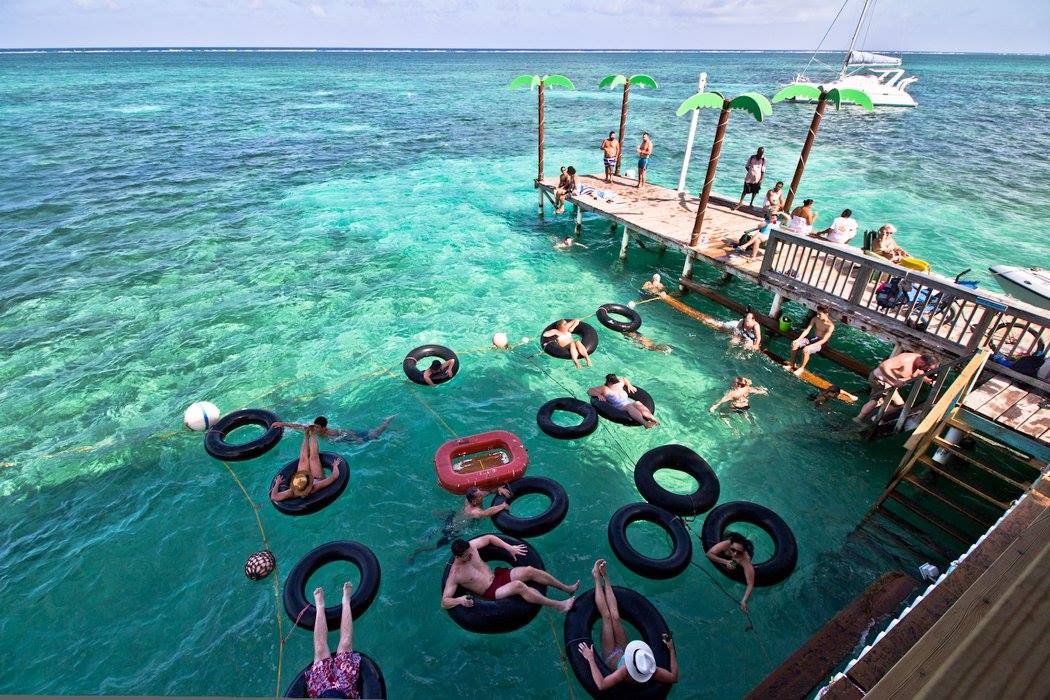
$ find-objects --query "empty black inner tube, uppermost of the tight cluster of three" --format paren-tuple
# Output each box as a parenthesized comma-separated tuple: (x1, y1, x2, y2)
(634, 445, 720, 515)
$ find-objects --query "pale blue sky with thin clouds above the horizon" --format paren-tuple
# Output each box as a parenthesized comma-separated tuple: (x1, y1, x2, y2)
(0, 0, 1050, 52)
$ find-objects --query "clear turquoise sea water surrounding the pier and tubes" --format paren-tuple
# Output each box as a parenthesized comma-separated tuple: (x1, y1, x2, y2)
(0, 51, 1050, 698)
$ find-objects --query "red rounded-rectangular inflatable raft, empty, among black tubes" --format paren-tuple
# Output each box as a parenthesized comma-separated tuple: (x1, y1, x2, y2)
(434, 430, 528, 493)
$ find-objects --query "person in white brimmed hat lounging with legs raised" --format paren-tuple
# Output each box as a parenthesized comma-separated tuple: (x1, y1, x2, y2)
(576, 559, 678, 691)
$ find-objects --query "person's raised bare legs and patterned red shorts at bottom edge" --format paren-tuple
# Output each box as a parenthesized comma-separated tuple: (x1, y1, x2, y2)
(307, 581, 361, 698)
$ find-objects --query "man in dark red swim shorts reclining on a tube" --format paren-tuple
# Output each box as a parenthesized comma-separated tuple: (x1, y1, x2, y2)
(441, 535, 580, 613)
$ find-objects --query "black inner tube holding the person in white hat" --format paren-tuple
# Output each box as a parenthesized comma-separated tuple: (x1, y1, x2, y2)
(563, 586, 671, 700)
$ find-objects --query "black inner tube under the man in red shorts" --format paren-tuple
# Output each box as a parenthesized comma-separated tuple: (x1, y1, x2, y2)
(441, 535, 547, 634)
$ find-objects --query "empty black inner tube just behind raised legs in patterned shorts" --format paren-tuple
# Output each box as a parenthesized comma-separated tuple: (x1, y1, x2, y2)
(285, 539, 380, 630)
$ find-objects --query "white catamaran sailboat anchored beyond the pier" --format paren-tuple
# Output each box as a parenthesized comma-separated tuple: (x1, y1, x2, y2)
(791, 0, 919, 107)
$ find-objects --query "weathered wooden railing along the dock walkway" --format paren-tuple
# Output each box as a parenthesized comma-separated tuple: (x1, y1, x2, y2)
(759, 229, 1050, 389)
